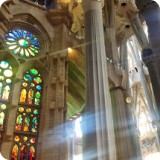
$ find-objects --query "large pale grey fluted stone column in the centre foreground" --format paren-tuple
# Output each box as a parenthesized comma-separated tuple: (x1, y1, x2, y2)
(84, 0, 116, 160)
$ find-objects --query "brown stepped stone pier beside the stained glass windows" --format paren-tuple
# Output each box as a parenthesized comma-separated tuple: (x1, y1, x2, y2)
(39, 24, 68, 160)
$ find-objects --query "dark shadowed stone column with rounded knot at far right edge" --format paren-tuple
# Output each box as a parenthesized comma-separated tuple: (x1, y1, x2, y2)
(137, 0, 160, 140)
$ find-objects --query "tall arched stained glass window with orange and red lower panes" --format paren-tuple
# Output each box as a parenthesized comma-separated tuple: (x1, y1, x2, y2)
(11, 68, 42, 160)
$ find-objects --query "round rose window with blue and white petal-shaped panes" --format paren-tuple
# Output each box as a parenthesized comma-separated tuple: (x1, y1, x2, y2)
(6, 29, 40, 58)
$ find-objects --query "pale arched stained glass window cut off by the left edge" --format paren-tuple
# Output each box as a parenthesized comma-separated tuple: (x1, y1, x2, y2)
(0, 61, 13, 139)
